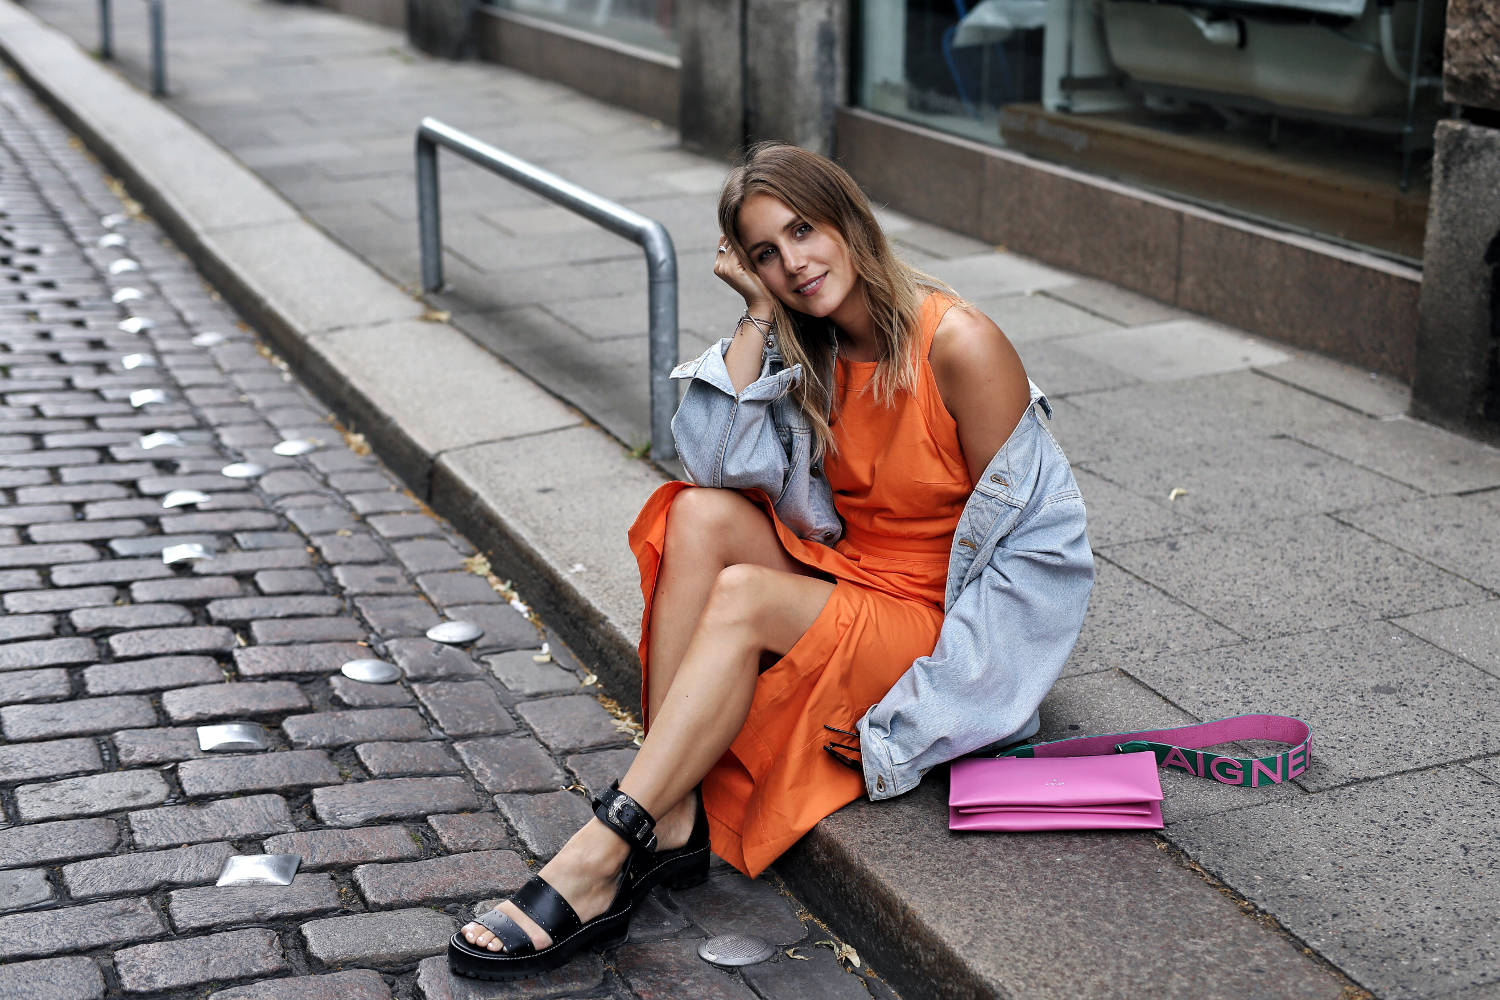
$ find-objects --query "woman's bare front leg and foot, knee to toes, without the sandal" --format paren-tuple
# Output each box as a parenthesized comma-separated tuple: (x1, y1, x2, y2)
(464, 564, 834, 951)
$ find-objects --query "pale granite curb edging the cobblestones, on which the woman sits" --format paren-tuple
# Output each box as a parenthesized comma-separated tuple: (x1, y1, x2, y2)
(0, 3, 1362, 997)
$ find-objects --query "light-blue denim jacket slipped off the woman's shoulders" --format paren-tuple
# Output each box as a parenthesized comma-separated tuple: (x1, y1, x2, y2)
(672, 339, 1094, 799)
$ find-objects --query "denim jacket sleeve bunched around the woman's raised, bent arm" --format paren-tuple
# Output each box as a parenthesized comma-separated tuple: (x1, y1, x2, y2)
(672, 337, 843, 546)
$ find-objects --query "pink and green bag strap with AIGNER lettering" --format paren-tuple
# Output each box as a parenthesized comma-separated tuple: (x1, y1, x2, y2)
(1001, 715, 1313, 789)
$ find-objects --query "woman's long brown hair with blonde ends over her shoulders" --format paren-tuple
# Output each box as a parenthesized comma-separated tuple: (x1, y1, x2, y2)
(719, 141, 953, 454)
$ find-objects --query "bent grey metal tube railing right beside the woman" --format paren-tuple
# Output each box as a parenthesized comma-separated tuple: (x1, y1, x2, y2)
(417, 118, 677, 460)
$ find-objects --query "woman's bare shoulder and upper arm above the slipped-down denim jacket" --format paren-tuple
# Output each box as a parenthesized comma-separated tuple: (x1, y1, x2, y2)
(929, 306, 1031, 483)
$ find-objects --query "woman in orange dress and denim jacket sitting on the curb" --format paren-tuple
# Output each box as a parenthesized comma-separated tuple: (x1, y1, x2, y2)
(449, 144, 1094, 979)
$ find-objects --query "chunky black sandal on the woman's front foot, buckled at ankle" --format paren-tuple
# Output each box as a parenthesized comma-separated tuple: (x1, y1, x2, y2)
(449, 786, 656, 981)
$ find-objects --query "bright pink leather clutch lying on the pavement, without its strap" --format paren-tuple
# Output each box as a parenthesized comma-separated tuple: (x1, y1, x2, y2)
(948, 751, 1163, 832)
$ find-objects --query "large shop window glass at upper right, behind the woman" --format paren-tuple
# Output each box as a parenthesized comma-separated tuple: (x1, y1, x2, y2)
(854, 0, 1445, 261)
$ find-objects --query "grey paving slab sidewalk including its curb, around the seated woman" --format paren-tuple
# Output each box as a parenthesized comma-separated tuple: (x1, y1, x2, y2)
(0, 0, 1500, 1000)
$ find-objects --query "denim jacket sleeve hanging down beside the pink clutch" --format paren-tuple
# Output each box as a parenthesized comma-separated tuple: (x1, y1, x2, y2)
(858, 385, 1094, 799)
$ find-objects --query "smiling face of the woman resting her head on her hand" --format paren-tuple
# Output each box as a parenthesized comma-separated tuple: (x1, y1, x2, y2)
(738, 192, 860, 316)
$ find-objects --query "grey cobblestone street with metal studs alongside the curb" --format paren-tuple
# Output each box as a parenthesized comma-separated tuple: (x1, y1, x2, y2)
(0, 76, 894, 1000)
